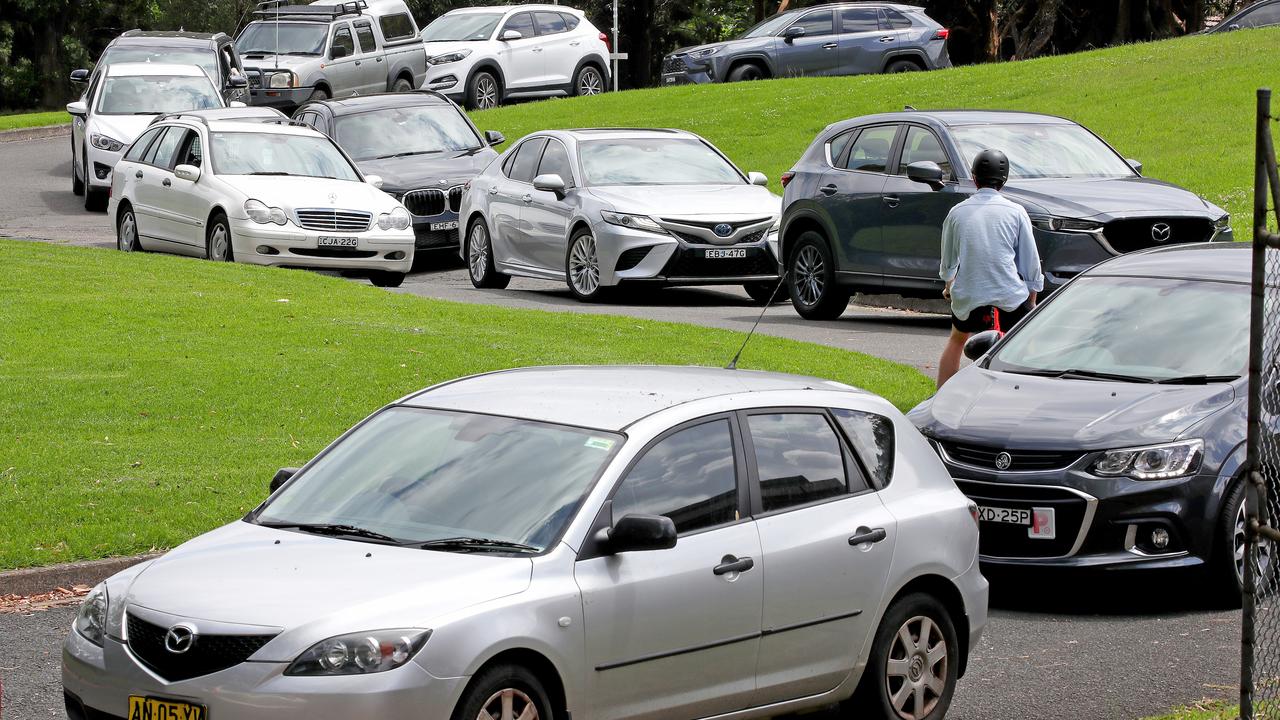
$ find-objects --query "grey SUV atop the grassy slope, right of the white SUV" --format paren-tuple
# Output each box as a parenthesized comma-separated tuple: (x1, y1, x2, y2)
(662, 3, 951, 85)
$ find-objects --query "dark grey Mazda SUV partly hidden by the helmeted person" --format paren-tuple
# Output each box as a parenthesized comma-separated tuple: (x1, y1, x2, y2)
(781, 110, 1233, 319)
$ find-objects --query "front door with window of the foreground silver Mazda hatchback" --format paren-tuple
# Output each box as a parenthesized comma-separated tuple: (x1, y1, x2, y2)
(573, 415, 764, 720)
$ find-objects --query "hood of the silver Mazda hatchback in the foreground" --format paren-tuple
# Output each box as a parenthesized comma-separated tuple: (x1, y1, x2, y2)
(122, 521, 532, 662)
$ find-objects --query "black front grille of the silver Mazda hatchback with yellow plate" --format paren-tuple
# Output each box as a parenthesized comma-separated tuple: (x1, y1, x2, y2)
(128, 614, 275, 683)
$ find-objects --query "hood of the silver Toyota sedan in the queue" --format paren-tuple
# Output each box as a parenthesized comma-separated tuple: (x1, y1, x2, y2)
(589, 184, 782, 219)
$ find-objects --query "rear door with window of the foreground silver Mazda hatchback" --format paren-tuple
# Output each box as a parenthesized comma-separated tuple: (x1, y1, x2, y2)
(740, 409, 897, 706)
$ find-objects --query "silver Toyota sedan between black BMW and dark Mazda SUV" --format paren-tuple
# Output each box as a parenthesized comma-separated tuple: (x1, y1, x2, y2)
(458, 128, 782, 302)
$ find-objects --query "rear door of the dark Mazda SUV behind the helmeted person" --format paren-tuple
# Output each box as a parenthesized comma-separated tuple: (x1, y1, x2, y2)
(818, 123, 899, 279)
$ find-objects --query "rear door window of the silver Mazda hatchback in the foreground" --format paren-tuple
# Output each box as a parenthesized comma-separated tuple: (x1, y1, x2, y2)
(746, 413, 865, 512)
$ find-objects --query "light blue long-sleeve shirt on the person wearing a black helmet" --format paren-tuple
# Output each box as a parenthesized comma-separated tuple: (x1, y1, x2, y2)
(938, 187, 1044, 320)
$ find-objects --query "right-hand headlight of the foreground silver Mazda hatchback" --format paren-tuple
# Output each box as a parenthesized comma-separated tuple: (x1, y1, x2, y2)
(284, 629, 431, 675)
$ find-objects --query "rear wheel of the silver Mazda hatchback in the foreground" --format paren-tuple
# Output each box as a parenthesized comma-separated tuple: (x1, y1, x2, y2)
(844, 593, 960, 720)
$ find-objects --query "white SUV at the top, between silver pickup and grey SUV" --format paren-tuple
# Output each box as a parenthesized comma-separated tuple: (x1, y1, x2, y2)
(422, 5, 609, 110)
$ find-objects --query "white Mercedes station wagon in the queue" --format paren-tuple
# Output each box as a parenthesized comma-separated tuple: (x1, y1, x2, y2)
(108, 114, 413, 287)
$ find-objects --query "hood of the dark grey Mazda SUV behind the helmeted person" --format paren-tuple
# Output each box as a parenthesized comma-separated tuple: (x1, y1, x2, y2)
(1004, 177, 1225, 220)
